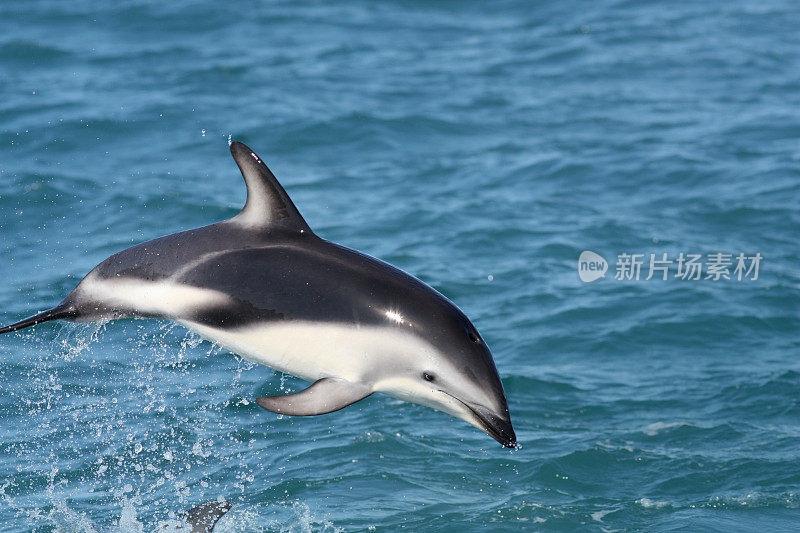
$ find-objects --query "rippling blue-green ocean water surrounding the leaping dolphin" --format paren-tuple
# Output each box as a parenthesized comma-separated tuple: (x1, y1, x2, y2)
(0, 0, 800, 532)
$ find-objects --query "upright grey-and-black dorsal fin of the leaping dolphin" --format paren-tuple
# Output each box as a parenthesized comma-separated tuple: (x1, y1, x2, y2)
(231, 141, 311, 233)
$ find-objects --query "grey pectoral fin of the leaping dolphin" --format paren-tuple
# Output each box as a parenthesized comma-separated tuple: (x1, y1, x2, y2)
(256, 378, 372, 416)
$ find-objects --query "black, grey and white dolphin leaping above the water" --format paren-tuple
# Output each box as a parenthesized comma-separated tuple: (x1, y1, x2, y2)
(0, 142, 516, 447)
